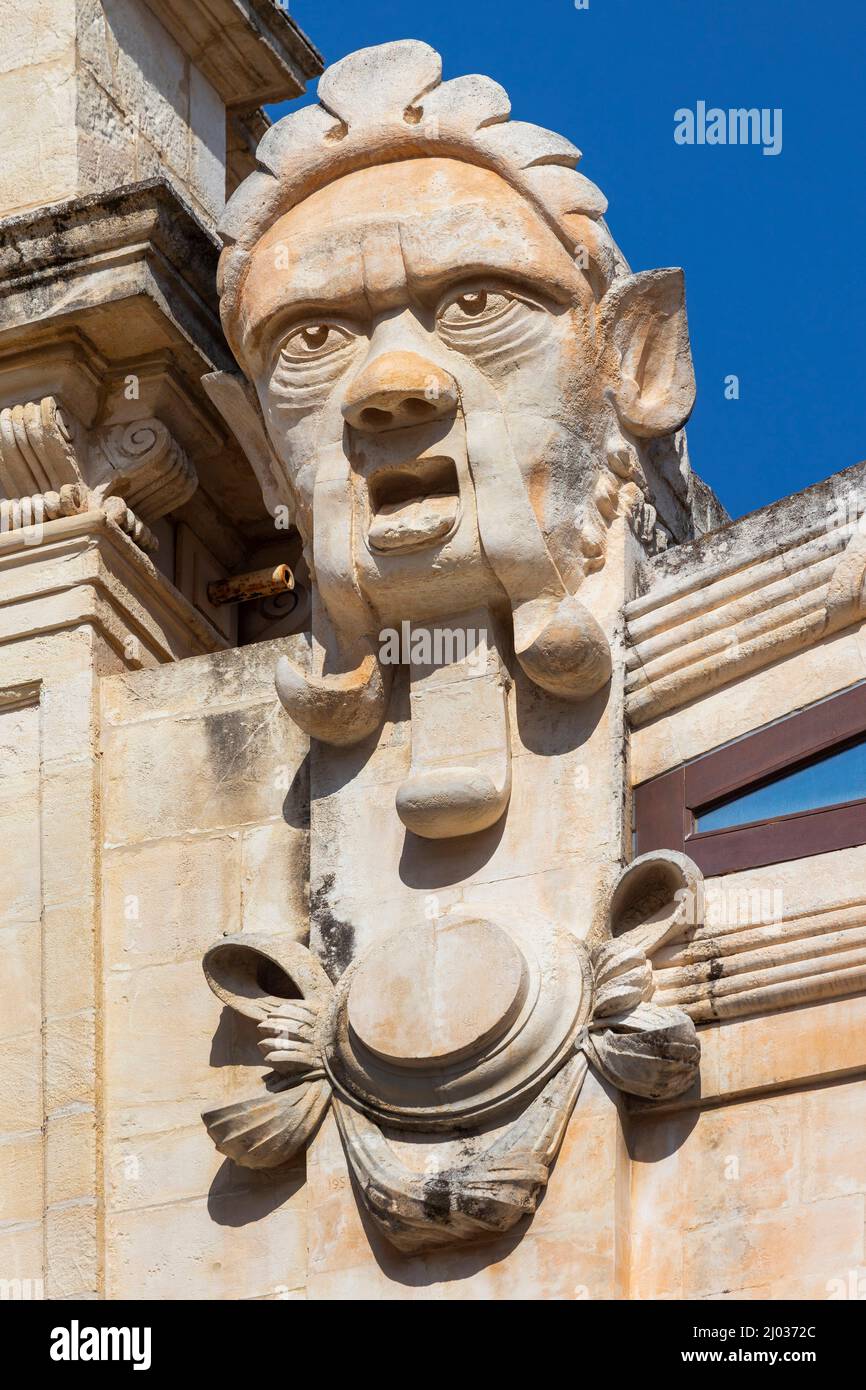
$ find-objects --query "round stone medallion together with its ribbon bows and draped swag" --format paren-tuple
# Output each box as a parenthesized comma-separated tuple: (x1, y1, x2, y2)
(203, 852, 702, 1252)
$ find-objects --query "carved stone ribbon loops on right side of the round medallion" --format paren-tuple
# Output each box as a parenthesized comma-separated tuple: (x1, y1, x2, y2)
(584, 851, 703, 1099)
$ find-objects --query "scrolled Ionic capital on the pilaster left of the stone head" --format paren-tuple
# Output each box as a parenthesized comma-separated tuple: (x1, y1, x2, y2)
(0, 396, 197, 550)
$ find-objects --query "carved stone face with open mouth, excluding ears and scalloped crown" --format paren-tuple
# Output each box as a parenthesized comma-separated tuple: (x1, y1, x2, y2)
(233, 158, 610, 623)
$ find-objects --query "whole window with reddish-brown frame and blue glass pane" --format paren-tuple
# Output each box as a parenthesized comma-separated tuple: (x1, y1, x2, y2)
(635, 684, 866, 874)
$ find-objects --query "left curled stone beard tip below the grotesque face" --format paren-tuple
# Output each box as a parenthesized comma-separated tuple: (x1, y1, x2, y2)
(275, 642, 391, 746)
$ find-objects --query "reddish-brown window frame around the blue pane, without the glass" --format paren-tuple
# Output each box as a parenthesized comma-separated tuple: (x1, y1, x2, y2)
(634, 681, 866, 874)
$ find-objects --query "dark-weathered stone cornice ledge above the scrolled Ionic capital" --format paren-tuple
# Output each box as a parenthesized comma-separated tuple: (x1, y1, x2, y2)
(0, 178, 279, 556)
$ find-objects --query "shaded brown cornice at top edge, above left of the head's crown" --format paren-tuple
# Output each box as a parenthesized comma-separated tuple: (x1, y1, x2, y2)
(147, 0, 322, 107)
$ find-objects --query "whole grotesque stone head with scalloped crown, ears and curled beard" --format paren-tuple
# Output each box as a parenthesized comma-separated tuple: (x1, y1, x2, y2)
(209, 42, 695, 838)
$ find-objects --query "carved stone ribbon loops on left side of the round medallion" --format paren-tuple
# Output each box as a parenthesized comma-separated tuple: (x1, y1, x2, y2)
(202, 933, 334, 1168)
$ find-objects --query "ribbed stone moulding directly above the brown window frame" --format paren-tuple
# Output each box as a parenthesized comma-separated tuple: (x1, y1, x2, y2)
(626, 464, 866, 726)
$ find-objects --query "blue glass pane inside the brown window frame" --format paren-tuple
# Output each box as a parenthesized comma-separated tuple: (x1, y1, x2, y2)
(695, 739, 866, 831)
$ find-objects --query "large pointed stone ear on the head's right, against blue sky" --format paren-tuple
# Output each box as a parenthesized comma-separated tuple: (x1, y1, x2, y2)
(601, 262, 695, 438)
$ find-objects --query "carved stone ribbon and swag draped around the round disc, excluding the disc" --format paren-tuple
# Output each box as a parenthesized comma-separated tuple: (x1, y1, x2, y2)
(203, 852, 701, 1251)
